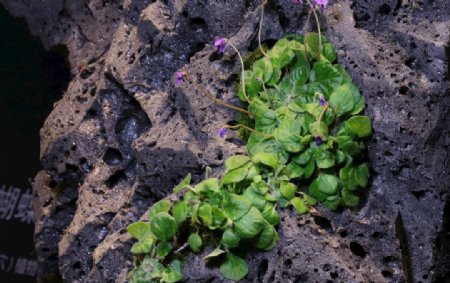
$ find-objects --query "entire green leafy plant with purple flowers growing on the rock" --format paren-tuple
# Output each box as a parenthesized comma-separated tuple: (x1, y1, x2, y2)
(128, 1, 372, 282)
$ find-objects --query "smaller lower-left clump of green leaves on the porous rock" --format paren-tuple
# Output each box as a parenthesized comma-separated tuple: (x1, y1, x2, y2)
(128, 160, 279, 282)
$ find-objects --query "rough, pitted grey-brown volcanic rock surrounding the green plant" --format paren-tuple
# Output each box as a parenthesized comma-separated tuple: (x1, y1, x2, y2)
(0, 0, 450, 282)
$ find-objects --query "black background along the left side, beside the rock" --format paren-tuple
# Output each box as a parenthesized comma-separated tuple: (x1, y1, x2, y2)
(0, 5, 70, 282)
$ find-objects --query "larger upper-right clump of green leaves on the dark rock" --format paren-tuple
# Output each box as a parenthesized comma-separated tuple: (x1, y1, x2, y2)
(239, 33, 372, 213)
